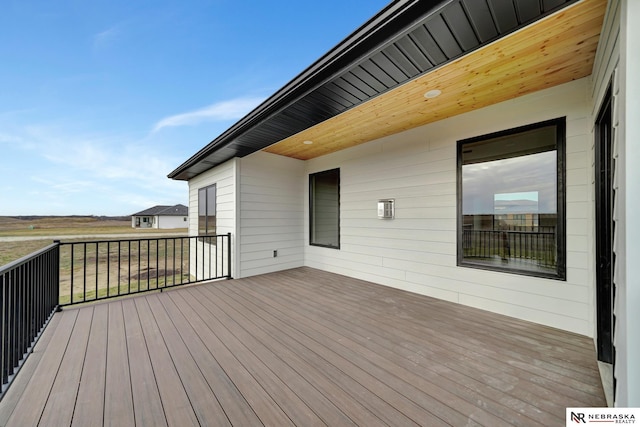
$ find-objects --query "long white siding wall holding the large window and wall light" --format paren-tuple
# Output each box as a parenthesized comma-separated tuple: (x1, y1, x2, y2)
(304, 79, 594, 336)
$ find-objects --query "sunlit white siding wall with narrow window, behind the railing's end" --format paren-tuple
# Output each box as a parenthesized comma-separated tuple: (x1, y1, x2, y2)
(189, 159, 238, 278)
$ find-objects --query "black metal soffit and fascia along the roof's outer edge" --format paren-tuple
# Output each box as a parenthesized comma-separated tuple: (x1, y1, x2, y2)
(169, 0, 577, 180)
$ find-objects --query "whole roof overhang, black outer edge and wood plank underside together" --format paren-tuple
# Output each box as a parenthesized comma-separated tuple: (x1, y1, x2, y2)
(169, 0, 606, 180)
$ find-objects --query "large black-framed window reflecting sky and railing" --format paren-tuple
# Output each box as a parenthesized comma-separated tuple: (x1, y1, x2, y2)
(458, 118, 565, 280)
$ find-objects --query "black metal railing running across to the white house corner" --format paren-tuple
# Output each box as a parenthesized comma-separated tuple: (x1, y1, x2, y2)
(60, 234, 231, 306)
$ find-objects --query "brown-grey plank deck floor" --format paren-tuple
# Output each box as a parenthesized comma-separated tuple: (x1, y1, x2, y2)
(0, 268, 605, 427)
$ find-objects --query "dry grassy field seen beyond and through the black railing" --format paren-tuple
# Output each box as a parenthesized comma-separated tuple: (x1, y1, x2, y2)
(0, 216, 198, 304)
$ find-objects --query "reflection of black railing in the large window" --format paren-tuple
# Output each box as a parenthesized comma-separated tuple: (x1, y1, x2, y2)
(462, 230, 557, 268)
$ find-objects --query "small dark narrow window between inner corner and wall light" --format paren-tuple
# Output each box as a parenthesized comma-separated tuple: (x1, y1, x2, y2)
(309, 169, 340, 249)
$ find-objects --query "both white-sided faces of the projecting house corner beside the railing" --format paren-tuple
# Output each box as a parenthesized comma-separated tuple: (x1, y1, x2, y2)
(189, 152, 305, 278)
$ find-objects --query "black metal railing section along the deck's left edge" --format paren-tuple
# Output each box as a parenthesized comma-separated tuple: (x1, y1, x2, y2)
(0, 243, 60, 399)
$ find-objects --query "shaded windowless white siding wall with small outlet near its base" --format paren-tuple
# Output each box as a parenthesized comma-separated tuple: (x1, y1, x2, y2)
(237, 152, 307, 277)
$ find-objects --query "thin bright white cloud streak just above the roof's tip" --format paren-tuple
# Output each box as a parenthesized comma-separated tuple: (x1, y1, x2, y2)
(153, 97, 263, 132)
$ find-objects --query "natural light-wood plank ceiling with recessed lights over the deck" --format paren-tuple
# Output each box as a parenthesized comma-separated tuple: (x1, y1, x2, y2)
(263, 0, 606, 160)
